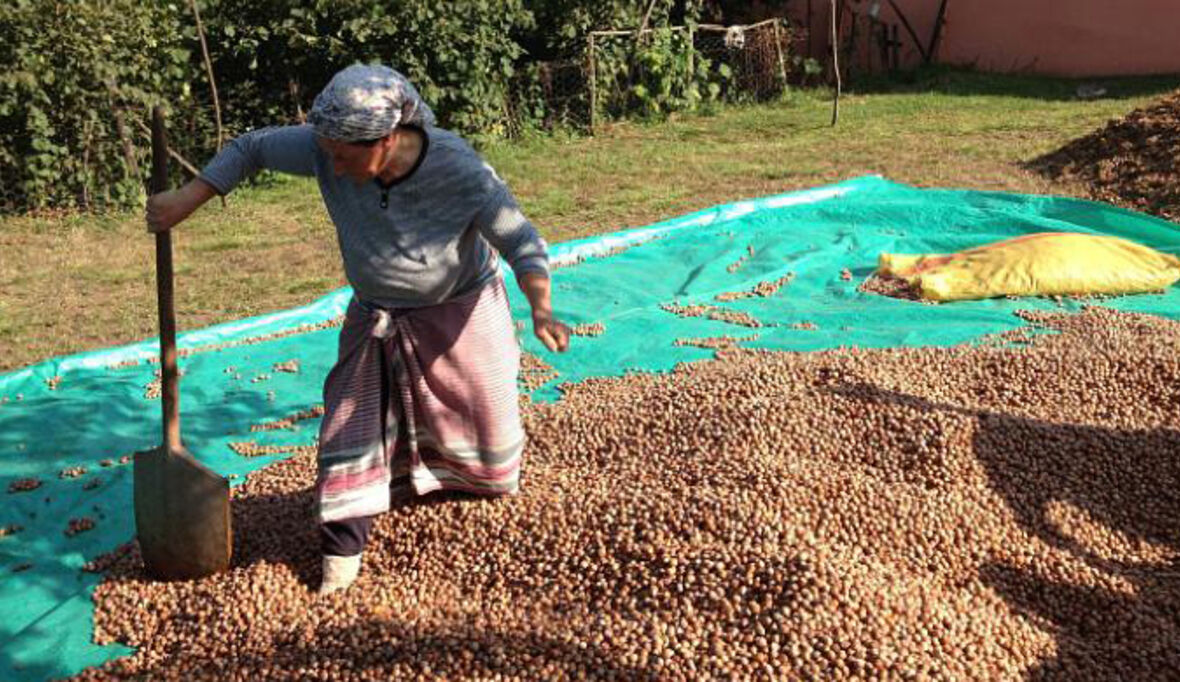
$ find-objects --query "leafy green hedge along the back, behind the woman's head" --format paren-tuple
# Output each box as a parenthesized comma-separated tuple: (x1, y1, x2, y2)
(0, 0, 792, 212)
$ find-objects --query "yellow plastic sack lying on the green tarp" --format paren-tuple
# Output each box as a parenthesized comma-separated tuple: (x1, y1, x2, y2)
(877, 232, 1180, 301)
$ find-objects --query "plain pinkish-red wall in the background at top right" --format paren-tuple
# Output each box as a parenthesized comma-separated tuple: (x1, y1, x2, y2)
(789, 0, 1180, 77)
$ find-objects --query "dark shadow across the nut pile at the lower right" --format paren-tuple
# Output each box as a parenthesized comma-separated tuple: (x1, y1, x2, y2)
(832, 383, 1180, 681)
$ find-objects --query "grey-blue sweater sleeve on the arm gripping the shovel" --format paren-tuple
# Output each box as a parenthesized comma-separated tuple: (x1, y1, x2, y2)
(201, 125, 319, 195)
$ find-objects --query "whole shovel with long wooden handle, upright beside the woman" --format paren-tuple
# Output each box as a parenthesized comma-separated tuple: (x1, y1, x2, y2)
(135, 106, 232, 581)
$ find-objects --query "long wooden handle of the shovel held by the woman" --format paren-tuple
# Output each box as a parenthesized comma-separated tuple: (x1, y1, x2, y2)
(151, 106, 181, 452)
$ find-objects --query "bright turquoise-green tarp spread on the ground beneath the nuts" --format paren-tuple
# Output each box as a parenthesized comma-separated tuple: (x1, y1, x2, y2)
(0, 177, 1180, 680)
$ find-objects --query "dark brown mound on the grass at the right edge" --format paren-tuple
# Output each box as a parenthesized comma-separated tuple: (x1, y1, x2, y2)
(1027, 91, 1180, 222)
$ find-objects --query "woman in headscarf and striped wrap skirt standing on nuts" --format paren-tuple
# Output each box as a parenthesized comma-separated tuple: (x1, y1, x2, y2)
(146, 65, 570, 594)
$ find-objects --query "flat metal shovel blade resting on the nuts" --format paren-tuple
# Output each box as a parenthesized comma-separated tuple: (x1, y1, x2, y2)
(135, 445, 232, 581)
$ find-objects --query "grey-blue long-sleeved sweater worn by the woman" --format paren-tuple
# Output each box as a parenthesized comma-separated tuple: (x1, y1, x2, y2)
(201, 125, 549, 308)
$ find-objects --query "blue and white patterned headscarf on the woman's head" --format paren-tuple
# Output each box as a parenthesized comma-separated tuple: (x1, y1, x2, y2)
(307, 64, 434, 142)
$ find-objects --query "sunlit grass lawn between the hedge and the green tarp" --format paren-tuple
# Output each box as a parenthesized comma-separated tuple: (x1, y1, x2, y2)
(0, 70, 1180, 372)
